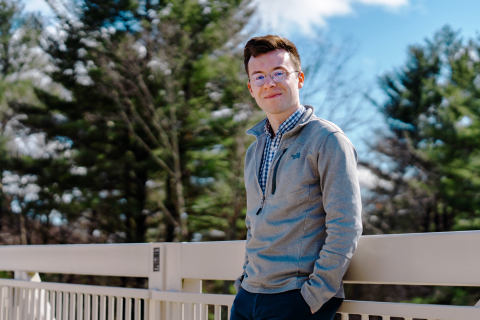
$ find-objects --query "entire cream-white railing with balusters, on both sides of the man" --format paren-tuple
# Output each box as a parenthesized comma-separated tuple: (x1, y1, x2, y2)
(0, 231, 480, 320)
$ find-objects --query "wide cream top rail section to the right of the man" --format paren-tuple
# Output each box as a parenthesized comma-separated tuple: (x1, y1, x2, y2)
(344, 231, 480, 286)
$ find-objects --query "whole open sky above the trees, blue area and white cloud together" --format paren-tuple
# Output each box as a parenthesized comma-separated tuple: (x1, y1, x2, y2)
(26, 0, 480, 154)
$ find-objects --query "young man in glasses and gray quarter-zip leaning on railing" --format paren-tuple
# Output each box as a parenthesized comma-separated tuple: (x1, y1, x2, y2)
(230, 35, 362, 320)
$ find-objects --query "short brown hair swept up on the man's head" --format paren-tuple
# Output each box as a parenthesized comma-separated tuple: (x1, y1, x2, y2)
(243, 34, 302, 75)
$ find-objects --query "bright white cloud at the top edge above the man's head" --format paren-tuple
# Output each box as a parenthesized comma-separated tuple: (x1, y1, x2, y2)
(254, 0, 409, 31)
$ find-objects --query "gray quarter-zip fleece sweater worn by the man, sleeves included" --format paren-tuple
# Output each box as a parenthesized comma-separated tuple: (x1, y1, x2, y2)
(234, 105, 362, 311)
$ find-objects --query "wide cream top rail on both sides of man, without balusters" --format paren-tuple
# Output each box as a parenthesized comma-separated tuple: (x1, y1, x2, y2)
(0, 231, 480, 286)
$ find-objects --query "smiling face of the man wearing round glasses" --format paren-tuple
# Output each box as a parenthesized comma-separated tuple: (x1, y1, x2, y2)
(247, 49, 304, 116)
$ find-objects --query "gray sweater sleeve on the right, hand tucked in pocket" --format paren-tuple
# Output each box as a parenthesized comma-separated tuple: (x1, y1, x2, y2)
(301, 132, 362, 312)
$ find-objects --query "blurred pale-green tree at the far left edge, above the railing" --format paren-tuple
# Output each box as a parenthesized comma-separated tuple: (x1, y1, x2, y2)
(0, 0, 46, 244)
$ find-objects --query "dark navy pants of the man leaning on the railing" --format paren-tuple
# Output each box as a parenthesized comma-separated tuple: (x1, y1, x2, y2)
(230, 288, 343, 320)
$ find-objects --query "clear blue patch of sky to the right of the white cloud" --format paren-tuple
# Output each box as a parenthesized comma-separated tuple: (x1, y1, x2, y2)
(326, 0, 480, 80)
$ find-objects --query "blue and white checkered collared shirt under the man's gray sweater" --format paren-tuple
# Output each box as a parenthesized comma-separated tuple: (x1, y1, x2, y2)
(258, 106, 306, 194)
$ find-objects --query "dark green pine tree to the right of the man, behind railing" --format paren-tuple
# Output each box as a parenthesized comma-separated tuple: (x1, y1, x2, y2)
(364, 26, 480, 232)
